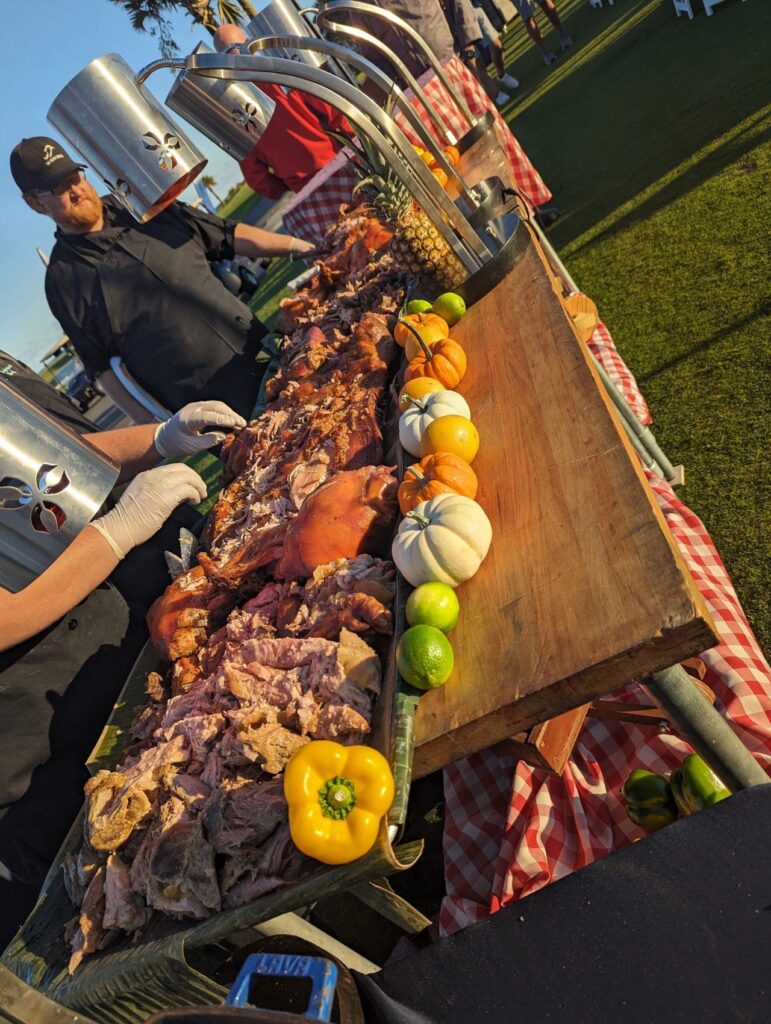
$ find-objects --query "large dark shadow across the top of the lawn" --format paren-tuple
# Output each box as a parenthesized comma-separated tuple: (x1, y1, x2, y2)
(499, 2, 771, 247)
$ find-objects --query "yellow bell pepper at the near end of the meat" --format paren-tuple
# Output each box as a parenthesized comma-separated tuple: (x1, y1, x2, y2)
(284, 739, 393, 864)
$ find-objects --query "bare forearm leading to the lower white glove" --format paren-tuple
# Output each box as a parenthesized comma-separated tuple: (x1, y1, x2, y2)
(0, 526, 118, 650)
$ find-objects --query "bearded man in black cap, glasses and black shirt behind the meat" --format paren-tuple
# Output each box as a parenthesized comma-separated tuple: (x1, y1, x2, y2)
(10, 136, 315, 423)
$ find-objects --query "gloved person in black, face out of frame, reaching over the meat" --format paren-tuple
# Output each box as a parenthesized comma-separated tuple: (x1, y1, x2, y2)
(0, 352, 245, 950)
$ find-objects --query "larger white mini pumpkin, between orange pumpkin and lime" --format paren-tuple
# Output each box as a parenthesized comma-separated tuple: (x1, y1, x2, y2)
(391, 495, 492, 587)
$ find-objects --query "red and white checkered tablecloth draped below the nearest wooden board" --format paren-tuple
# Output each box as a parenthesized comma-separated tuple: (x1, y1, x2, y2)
(440, 470, 771, 934)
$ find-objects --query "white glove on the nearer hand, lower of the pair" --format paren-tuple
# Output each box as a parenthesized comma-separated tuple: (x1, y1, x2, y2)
(91, 462, 206, 558)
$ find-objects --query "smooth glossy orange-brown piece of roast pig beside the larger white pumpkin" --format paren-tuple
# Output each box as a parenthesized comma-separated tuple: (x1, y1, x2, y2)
(274, 466, 397, 580)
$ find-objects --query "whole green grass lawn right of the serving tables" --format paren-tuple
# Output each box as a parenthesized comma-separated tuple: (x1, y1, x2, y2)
(495, 0, 771, 650)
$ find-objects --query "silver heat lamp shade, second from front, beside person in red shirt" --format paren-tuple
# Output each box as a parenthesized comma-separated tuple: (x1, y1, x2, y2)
(166, 43, 275, 161)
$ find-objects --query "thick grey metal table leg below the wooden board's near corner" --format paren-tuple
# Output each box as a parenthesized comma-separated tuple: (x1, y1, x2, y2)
(645, 665, 771, 793)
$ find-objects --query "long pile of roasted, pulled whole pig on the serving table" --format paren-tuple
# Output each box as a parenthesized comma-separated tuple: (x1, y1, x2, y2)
(62, 203, 405, 970)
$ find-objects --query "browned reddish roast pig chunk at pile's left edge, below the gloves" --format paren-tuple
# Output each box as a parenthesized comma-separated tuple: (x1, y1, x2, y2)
(147, 565, 235, 662)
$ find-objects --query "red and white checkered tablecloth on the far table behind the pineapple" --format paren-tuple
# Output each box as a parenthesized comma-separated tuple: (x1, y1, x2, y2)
(282, 57, 552, 244)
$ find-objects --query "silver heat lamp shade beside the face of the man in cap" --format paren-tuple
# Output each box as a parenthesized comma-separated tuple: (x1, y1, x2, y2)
(48, 53, 206, 223)
